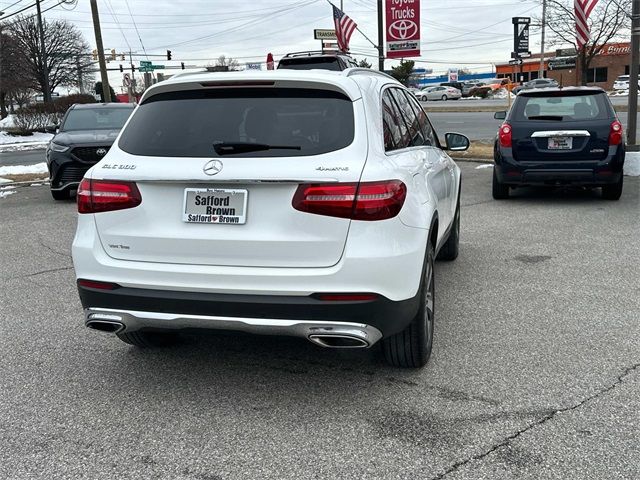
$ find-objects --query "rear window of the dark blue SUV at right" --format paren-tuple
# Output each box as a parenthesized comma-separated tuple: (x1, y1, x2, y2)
(513, 93, 610, 121)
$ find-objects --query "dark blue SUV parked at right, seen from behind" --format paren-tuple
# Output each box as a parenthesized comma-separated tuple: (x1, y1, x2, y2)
(493, 87, 625, 200)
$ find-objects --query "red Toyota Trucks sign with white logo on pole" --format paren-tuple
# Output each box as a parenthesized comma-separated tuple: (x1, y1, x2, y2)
(386, 0, 420, 58)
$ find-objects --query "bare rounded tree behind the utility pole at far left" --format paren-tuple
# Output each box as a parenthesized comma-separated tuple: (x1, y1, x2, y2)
(9, 17, 89, 97)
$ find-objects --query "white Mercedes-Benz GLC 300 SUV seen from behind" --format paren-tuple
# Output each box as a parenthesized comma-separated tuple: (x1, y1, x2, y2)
(73, 69, 469, 367)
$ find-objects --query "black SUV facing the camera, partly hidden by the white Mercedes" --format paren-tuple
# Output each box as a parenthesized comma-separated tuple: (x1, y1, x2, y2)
(46, 103, 135, 200)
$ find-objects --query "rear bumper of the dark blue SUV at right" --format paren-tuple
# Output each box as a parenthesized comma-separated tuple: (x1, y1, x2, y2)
(494, 147, 624, 187)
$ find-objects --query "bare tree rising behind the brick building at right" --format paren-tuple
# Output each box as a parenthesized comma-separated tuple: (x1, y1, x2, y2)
(537, 0, 631, 85)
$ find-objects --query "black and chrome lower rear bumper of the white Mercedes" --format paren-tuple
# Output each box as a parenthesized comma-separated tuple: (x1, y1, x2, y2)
(78, 286, 419, 340)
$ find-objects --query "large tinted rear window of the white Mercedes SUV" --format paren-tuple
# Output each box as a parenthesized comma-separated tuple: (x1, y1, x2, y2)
(118, 87, 354, 158)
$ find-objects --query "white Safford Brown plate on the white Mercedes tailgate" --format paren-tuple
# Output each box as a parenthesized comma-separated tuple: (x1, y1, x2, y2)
(182, 188, 248, 225)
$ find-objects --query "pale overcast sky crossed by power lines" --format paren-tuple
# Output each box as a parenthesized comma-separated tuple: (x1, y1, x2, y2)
(0, 0, 552, 91)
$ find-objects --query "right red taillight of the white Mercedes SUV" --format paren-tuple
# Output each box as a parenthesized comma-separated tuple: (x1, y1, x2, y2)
(292, 180, 407, 221)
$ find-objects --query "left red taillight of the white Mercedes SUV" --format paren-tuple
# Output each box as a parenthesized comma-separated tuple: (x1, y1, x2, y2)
(78, 178, 142, 213)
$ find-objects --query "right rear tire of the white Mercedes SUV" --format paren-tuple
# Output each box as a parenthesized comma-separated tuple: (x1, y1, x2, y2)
(382, 243, 435, 368)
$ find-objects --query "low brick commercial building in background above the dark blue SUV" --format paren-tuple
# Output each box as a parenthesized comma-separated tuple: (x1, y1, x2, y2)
(496, 43, 631, 90)
